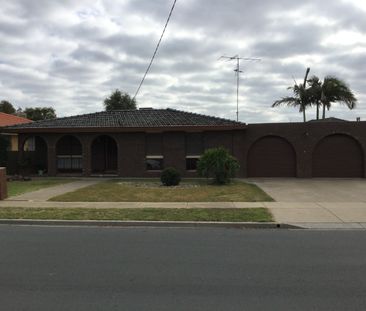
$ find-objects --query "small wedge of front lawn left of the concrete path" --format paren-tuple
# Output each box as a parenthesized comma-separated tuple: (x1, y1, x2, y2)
(8, 177, 76, 197)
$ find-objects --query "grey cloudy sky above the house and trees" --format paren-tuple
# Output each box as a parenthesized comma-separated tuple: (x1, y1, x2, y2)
(0, 0, 366, 123)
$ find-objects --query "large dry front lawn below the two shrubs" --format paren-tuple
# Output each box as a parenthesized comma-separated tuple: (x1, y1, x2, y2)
(50, 180, 273, 202)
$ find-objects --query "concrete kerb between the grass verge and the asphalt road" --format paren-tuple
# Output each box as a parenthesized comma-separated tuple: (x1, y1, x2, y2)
(0, 219, 305, 229)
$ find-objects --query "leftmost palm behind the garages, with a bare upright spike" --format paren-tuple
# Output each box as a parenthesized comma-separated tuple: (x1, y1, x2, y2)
(272, 68, 312, 122)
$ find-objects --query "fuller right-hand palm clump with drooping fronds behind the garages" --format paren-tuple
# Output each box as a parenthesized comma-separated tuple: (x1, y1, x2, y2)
(309, 76, 357, 119)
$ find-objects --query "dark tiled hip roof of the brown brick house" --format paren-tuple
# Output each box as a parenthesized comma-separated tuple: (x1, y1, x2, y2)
(3, 108, 244, 129)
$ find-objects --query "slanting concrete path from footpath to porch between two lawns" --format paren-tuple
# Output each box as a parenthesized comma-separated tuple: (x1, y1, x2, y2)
(3, 179, 101, 203)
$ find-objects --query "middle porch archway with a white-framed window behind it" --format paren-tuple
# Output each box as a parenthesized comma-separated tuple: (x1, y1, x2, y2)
(56, 135, 83, 173)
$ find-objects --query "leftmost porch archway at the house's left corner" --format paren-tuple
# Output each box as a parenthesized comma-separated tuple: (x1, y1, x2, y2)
(20, 136, 48, 174)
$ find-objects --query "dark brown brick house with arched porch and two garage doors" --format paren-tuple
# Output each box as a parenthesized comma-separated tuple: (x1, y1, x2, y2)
(4, 108, 366, 177)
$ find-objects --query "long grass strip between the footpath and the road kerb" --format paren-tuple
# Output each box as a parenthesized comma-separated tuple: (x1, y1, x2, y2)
(0, 207, 273, 222)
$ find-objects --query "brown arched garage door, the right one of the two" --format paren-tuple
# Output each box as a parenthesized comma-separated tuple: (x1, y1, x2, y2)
(313, 134, 363, 177)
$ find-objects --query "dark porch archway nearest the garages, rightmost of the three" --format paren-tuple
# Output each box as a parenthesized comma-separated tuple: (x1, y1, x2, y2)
(91, 135, 118, 174)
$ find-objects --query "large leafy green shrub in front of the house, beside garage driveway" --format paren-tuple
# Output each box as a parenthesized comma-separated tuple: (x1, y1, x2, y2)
(197, 147, 240, 184)
